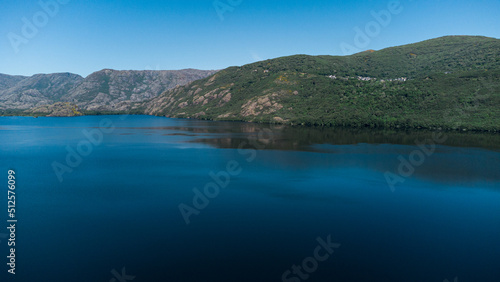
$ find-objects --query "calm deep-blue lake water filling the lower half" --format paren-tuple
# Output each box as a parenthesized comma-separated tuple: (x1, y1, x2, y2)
(0, 116, 500, 282)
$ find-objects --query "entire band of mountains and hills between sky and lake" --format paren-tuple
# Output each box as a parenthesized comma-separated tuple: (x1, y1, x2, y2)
(0, 36, 500, 131)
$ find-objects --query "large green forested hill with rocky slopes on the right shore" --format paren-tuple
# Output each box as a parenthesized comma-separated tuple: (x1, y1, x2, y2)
(141, 36, 500, 130)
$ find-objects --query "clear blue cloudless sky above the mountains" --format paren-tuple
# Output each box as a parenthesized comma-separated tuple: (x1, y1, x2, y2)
(0, 0, 500, 76)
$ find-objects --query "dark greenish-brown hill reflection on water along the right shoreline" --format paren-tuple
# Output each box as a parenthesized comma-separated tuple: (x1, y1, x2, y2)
(138, 121, 500, 151)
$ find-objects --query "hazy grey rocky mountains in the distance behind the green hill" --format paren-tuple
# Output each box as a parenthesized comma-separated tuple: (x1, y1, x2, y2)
(0, 69, 216, 114)
